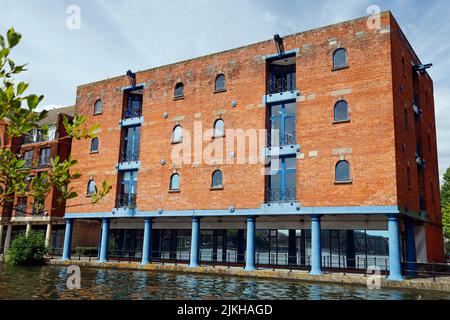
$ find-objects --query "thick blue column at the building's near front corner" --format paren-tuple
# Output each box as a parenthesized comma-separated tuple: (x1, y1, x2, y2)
(388, 215, 403, 281)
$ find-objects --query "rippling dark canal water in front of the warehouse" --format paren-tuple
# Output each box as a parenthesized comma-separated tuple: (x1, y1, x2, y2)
(0, 264, 450, 300)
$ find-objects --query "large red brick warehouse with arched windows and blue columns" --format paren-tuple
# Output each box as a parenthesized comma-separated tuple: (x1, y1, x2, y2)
(64, 12, 443, 280)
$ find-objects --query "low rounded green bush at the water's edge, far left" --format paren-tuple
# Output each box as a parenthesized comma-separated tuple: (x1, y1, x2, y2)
(6, 231, 47, 265)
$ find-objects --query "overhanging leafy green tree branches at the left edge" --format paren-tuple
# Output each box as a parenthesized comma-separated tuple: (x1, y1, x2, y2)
(0, 28, 111, 218)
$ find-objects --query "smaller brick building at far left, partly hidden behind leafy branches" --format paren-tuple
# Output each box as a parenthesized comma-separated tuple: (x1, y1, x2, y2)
(0, 106, 98, 252)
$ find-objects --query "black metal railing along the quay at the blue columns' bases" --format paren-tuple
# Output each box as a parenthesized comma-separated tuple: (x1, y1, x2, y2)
(44, 248, 450, 281)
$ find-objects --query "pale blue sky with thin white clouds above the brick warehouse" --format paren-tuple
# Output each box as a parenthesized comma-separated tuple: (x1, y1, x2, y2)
(0, 0, 450, 180)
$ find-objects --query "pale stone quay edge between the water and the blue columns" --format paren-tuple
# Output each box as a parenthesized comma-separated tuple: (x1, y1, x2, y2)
(48, 259, 450, 293)
